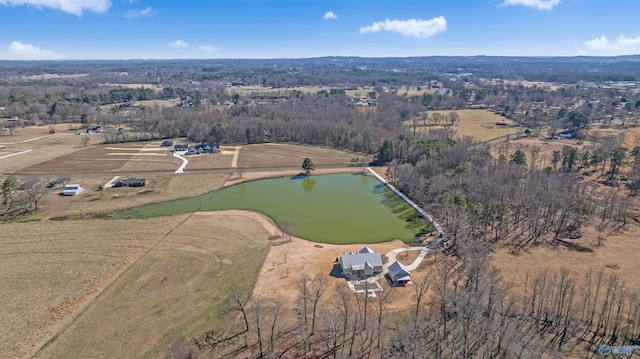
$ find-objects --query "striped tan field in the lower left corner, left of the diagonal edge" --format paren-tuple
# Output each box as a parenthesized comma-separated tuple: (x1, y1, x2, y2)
(0, 218, 178, 358)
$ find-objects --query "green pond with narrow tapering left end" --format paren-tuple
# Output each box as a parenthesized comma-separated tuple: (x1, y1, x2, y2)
(120, 173, 428, 244)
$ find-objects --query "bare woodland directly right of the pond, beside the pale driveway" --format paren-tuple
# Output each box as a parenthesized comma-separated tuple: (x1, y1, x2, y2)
(376, 130, 590, 254)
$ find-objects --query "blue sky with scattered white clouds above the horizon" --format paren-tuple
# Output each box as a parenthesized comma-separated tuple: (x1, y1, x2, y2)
(0, 0, 640, 59)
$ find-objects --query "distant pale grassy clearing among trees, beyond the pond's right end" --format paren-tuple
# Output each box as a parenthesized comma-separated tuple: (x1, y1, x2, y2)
(405, 110, 524, 142)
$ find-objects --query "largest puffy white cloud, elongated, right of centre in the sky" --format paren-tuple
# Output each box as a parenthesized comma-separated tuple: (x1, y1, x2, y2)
(358, 16, 447, 39)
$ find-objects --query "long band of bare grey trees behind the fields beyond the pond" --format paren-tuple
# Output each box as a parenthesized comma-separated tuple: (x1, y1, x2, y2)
(98, 92, 412, 154)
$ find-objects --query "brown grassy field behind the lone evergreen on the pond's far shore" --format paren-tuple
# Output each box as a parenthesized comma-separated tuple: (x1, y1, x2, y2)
(238, 144, 372, 168)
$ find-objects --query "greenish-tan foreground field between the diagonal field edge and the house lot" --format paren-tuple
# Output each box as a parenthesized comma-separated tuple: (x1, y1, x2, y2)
(36, 213, 269, 358)
